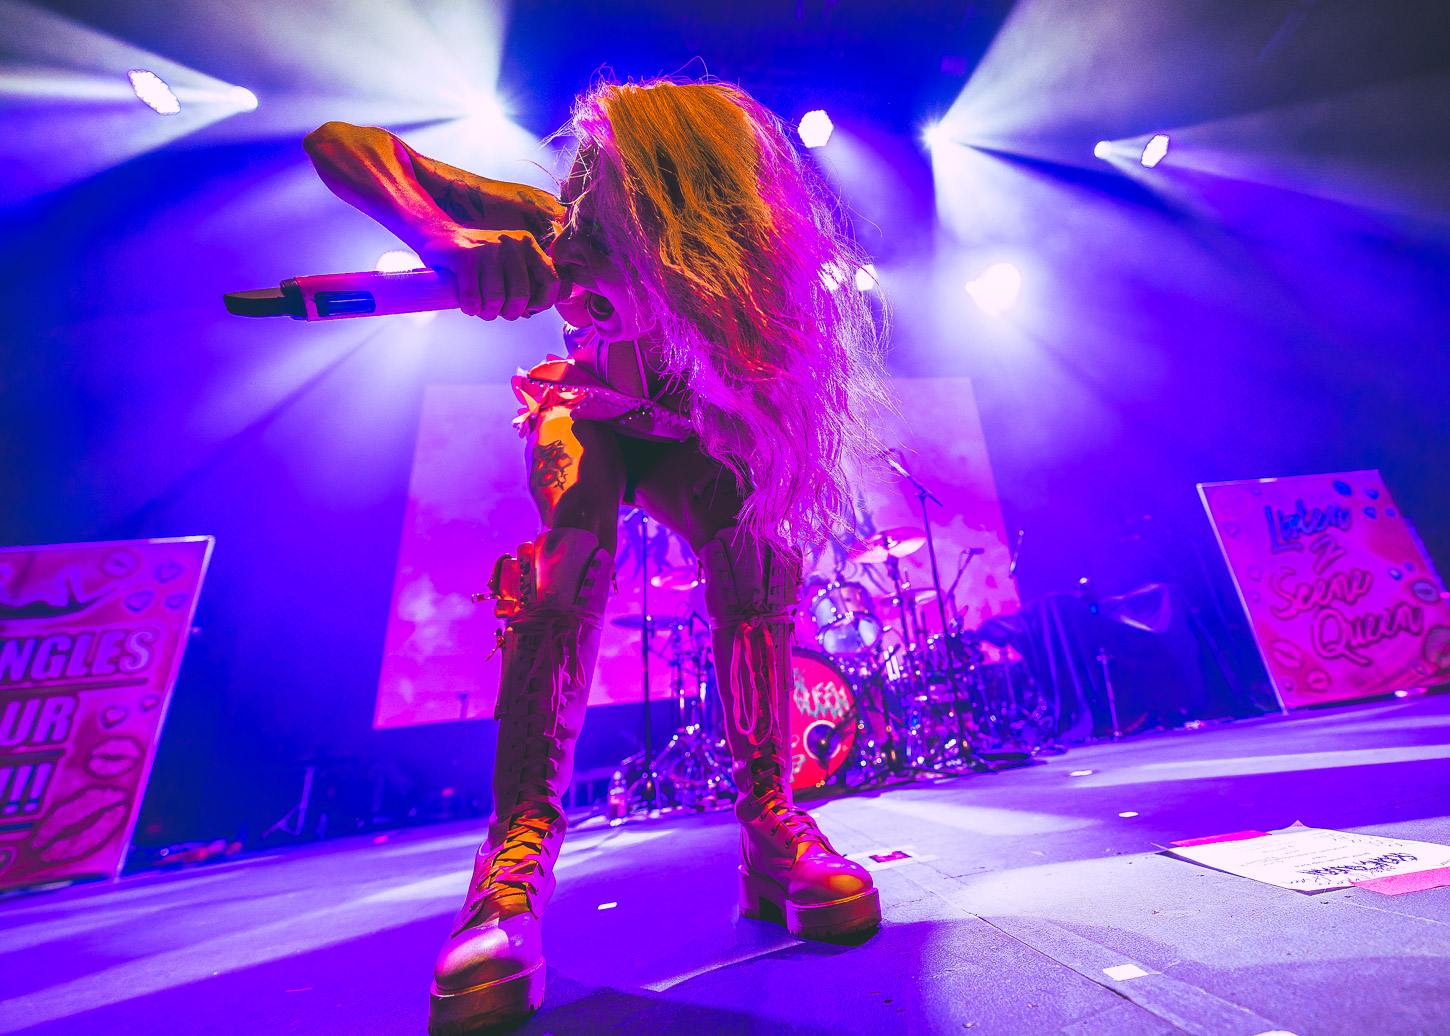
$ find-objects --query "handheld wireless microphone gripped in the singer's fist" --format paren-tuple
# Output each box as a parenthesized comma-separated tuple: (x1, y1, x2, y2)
(222, 270, 574, 321)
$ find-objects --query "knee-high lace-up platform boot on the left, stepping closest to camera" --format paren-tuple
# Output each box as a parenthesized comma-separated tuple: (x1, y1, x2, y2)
(428, 528, 613, 1036)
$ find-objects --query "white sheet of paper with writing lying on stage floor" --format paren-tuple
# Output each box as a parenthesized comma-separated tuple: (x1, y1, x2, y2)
(1169, 824, 1450, 892)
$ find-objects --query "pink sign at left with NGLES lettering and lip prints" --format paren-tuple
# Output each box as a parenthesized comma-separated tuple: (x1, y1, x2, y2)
(0, 535, 213, 888)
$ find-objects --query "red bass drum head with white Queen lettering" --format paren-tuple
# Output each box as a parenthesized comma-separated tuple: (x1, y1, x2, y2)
(790, 647, 857, 791)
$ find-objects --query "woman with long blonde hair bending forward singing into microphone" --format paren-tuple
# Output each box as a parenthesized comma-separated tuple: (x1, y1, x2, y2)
(306, 80, 885, 1036)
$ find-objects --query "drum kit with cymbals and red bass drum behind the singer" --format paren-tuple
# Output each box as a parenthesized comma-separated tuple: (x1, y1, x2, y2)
(606, 496, 1056, 823)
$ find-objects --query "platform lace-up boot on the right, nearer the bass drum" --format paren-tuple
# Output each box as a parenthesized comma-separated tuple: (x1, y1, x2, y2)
(700, 527, 882, 939)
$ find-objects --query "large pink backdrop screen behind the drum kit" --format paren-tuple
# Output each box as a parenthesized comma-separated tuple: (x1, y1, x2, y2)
(374, 379, 1018, 727)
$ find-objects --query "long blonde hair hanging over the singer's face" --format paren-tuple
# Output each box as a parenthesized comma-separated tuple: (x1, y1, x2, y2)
(568, 80, 889, 556)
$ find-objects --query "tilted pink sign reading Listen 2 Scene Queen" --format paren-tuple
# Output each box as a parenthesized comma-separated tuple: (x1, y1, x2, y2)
(1198, 472, 1450, 708)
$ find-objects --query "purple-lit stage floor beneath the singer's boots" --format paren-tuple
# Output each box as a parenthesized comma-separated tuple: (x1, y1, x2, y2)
(0, 684, 1450, 1036)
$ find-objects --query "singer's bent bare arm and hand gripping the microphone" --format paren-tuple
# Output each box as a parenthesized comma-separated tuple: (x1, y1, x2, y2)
(303, 122, 564, 319)
